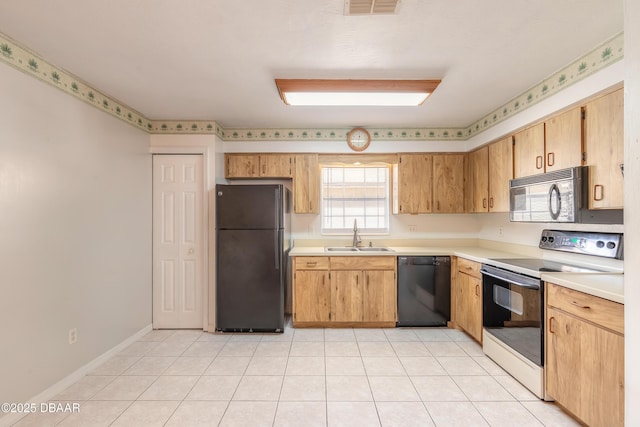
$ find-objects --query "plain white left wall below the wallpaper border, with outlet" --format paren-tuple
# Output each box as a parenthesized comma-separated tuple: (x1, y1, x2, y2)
(0, 63, 151, 412)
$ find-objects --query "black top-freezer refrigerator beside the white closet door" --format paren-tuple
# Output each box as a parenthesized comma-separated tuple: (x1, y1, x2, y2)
(216, 184, 291, 332)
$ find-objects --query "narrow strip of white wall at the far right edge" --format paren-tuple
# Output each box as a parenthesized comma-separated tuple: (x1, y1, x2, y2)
(624, 0, 640, 426)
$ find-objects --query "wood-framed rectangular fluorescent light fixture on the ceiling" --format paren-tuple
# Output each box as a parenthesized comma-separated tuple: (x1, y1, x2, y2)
(276, 79, 440, 107)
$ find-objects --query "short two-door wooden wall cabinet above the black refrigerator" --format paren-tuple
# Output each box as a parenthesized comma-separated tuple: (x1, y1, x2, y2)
(224, 154, 293, 178)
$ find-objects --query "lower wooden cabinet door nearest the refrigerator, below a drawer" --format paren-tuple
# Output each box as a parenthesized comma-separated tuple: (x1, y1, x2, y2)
(293, 270, 331, 322)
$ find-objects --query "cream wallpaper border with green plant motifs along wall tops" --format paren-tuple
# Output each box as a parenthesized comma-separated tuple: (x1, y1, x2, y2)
(0, 33, 624, 141)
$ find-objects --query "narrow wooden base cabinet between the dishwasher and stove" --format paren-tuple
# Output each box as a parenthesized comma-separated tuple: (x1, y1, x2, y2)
(454, 258, 482, 342)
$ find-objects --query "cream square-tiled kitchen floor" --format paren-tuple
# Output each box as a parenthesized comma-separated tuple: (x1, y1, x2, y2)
(15, 327, 578, 427)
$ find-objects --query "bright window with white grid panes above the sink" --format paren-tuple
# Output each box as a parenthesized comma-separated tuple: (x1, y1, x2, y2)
(321, 166, 389, 233)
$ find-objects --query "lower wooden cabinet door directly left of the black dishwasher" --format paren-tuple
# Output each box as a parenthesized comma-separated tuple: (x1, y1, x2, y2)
(363, 271, 397, 322)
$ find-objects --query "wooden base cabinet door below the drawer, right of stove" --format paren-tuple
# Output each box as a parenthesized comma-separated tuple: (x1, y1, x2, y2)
(545, 307, 624, 427)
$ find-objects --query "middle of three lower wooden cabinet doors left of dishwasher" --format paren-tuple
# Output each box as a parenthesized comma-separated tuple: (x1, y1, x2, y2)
(331, 270, 364, 322)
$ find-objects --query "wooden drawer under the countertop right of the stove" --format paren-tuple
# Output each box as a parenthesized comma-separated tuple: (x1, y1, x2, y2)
(546, 282, 624, 334)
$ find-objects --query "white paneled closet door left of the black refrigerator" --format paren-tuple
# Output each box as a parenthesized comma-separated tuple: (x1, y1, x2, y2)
(153, 155, 204, 328)
